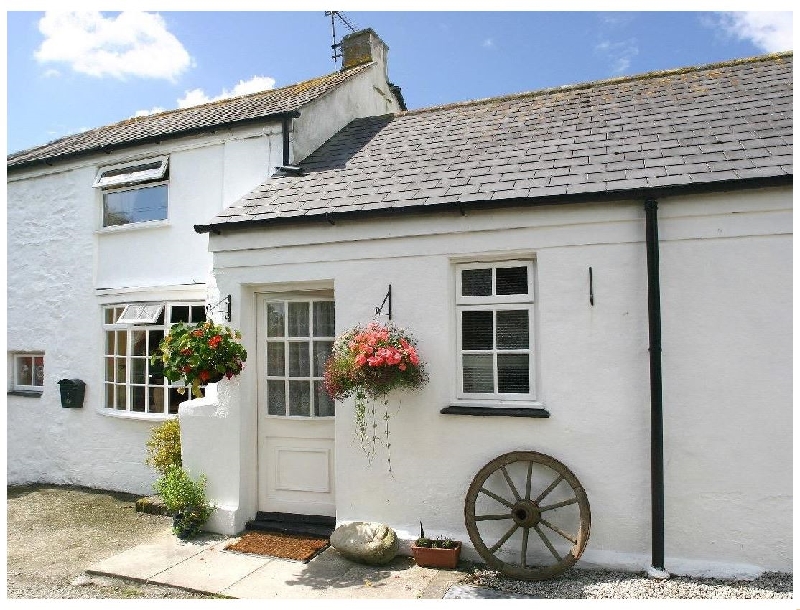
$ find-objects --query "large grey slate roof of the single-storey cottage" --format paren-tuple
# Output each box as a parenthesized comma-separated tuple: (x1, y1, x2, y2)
(202, 53, 793, 232)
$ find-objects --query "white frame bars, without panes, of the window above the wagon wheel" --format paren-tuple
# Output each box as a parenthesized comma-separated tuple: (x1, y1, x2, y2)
(455, 259, 541, 407)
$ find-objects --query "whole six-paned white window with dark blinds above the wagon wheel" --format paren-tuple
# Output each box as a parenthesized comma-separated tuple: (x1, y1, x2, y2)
(456, 261, 536, 402)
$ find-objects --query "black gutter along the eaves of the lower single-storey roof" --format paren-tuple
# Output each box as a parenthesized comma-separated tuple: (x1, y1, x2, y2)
(194, 173, 792, 234)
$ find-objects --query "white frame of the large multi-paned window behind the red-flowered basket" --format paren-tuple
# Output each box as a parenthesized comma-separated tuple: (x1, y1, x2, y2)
(99, 300, 207, 419)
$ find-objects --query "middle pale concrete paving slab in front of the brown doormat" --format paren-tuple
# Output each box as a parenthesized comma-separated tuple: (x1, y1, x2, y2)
(150, 541, 276, 594)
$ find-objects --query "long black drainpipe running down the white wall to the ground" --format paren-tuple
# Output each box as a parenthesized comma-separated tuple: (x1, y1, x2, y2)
(644, 199, 665, 572)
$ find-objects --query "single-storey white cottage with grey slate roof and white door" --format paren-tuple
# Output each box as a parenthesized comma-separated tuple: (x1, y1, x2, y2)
(189, 54, 792, 576)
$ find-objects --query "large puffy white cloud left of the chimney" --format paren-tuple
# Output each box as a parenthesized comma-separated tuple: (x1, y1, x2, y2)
(34, 11, 192, 81)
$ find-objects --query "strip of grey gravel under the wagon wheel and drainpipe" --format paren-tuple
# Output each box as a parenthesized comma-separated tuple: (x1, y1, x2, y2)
(464, 569, 792, 599)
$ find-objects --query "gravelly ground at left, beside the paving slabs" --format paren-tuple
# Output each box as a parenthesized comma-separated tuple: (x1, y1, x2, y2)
(6, 485, 219, 599)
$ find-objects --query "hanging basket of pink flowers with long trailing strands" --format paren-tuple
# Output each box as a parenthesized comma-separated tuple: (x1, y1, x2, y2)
(324, 321, 428, 472)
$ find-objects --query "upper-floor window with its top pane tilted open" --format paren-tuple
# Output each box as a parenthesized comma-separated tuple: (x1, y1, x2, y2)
(92, 157, 169, 227)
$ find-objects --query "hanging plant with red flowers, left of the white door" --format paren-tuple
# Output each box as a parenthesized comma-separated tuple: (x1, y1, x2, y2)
(150, 320, 247, 398)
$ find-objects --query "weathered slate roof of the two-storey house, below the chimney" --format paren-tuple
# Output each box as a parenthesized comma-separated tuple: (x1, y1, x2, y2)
(7, 63, 372, 170)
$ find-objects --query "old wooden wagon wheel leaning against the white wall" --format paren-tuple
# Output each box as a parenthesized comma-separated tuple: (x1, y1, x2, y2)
(464, 451, 591, 580)
